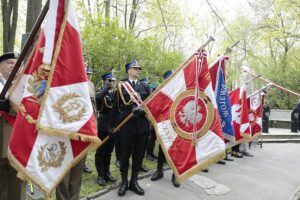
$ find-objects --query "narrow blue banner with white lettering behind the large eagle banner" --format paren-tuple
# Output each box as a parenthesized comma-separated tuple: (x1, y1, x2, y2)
(209, 56, 235, 148)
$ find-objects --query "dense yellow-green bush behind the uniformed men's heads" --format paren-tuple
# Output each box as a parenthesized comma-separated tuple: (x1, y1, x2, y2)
(81, 3, 183, 87)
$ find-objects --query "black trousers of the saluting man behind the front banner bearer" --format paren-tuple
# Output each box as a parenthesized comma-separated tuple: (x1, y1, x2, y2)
(95, 131, 115, 176)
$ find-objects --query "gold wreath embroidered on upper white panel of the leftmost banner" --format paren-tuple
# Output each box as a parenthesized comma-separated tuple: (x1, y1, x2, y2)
(52, 92, 87, 124)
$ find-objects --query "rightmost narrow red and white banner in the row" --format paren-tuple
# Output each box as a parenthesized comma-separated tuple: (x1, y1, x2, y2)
(247, 92, 263, 137)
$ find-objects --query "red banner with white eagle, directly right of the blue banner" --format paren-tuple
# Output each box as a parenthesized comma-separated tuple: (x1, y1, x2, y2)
(229, 86, 251, 144)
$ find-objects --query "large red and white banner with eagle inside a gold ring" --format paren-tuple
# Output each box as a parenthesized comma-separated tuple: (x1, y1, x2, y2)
(145, 50, 225, 182)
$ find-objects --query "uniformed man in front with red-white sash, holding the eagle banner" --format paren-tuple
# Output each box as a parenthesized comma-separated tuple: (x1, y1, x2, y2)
(110, 60, 150, 196)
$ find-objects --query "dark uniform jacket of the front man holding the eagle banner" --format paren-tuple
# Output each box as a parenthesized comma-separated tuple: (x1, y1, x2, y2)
(110, 80, 150, 133)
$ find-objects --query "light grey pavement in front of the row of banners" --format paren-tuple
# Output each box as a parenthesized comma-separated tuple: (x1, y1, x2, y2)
(88, 143, 300, 200)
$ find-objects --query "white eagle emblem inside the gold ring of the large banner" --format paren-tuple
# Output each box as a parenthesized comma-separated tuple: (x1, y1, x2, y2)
(179, 101, 203, 127)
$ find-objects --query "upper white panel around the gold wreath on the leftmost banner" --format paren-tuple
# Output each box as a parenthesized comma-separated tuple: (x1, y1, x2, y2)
(39, 82, 93, 131)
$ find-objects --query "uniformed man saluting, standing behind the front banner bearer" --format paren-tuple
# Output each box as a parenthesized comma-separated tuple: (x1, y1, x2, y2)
(95, 72, 117, 186)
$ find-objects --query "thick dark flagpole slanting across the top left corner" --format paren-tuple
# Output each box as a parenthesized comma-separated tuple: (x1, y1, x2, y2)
(0, 0, 49, 100)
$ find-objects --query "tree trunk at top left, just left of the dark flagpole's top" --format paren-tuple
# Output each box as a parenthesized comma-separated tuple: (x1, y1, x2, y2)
(26, 0, 42, 33)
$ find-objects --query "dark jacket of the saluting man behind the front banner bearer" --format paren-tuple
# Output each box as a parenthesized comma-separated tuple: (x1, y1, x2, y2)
(96, 85, 115, 132)
